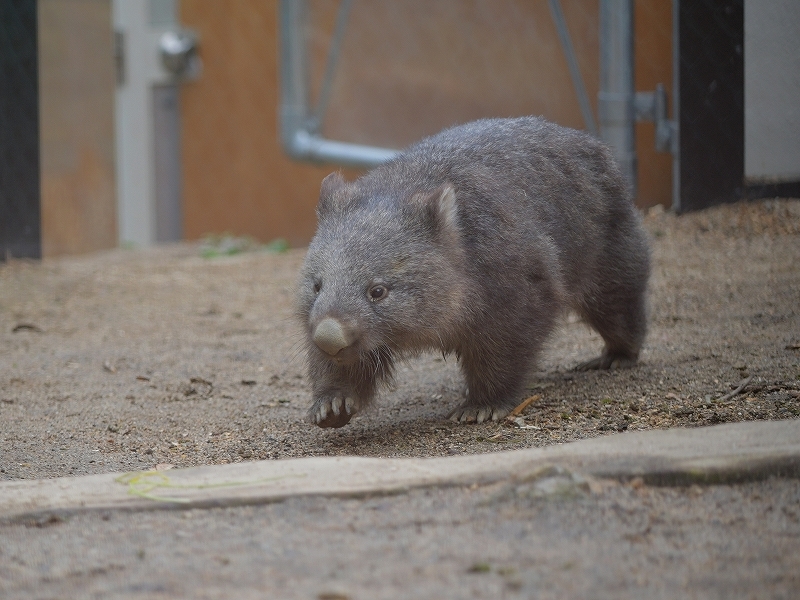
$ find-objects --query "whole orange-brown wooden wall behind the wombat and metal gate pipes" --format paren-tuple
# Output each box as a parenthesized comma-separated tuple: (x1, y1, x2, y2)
(181, 0, 671, 245)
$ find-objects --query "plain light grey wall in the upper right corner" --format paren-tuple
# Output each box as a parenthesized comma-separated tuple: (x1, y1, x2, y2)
(744, 0, 800, 183)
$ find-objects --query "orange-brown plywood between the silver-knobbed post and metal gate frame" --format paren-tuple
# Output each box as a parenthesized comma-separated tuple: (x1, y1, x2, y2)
(181, 0, 356, 245)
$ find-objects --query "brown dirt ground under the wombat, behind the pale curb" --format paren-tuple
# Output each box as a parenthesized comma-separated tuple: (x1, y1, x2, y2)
(0, 200, 800, 480)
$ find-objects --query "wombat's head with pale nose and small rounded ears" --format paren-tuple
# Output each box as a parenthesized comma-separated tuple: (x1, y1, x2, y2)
(298, 173, 466, 365)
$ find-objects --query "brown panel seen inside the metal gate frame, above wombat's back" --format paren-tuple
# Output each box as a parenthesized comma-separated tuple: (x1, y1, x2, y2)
(309, 0, 599, 148)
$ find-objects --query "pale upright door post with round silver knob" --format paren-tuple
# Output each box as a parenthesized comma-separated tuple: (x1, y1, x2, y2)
(112, 0, 201, 246)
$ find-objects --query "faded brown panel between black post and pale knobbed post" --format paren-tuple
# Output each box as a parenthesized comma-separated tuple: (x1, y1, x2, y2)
(38, 0, 117, 256)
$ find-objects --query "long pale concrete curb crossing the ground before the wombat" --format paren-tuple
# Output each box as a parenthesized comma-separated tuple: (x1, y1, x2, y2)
(0, 419, 800, 521)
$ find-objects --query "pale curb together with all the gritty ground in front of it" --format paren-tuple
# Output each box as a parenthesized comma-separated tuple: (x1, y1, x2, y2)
(0, 420, 800, 600)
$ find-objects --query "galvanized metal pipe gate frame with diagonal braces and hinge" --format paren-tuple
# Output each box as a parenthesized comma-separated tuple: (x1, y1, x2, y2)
(279, 0, 678, 193)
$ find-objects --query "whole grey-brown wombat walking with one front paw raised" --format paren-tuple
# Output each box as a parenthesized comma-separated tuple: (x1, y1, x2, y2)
(298, 117, 650, 427)
